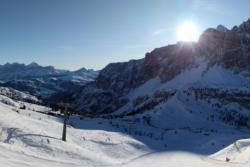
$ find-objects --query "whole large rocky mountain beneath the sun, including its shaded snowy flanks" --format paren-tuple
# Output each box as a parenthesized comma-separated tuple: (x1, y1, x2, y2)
(75, 20, 250, 126)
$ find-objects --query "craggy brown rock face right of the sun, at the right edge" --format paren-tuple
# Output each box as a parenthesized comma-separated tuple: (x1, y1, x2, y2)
(198, 29, 250, 70)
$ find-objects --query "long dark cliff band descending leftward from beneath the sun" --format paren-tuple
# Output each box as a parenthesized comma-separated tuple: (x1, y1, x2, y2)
(95, 43, 197, 95)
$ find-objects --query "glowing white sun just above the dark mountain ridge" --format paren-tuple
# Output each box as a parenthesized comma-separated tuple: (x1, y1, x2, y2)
(177, 21, 199, 42)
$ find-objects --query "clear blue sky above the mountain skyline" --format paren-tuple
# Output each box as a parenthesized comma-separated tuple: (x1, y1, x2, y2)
(0, 0, 250, 70)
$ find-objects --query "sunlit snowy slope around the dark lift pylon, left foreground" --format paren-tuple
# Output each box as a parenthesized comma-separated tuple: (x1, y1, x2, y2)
(0, 94, 149, 167)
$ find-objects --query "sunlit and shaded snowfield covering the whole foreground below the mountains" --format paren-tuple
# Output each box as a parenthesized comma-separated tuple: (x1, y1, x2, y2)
(0, 97, 250, 167)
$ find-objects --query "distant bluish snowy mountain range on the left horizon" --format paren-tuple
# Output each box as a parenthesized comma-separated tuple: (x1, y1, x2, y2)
(0, 63, 98, 99)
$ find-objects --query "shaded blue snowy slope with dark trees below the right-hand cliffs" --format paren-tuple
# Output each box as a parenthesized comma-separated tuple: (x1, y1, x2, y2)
(108, 60, 250, 129)
